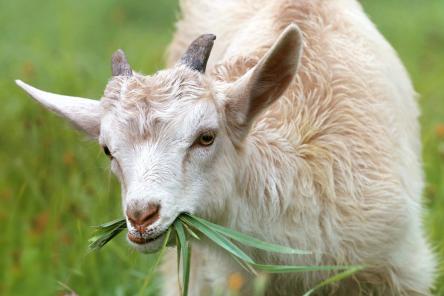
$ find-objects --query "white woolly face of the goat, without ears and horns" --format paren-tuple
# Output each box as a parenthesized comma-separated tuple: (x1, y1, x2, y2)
(99, 66, 234, 251)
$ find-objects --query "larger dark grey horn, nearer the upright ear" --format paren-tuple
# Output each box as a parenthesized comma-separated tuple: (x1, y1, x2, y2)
(180, 34, 216, 73)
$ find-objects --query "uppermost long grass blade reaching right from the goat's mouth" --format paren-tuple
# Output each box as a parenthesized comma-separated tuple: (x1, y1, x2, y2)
(186, 214, 311, 255)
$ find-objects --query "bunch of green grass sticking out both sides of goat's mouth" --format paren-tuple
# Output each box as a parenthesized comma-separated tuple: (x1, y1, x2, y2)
(89, 214, 364, 296)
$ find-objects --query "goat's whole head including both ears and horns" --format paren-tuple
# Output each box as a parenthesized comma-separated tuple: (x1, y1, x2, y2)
(17, 25, 302, 252)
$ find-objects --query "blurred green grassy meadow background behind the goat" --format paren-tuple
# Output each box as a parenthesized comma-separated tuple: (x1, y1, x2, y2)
(0, 0, 444, 295)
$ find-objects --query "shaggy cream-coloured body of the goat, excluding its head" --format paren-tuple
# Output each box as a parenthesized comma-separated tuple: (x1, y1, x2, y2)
(163, 0, 434, 295)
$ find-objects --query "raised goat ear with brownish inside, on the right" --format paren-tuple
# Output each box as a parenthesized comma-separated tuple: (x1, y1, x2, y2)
(225, 24, 302, 140)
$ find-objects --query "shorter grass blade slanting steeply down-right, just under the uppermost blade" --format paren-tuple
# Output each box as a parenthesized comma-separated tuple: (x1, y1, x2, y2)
(179, 215, 254, 264)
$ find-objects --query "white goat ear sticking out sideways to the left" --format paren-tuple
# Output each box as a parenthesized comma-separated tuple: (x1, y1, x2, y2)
(15, 80, 101, 138)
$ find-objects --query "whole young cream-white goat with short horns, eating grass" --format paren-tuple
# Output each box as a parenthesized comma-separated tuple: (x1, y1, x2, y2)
(17, 0, 435, 295)
